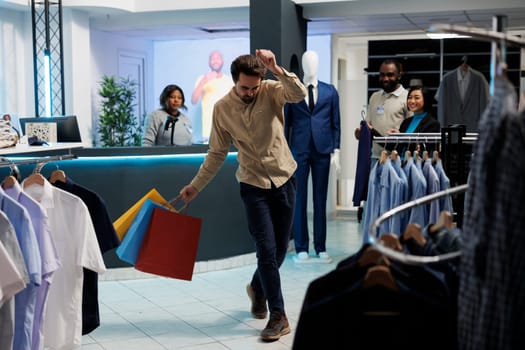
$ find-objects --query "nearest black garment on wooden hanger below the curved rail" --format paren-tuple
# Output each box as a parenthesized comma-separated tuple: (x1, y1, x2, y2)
(292, 246, 456, 350)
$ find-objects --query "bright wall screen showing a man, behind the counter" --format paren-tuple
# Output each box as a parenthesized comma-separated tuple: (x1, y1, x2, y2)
(154, 36, 331, 143)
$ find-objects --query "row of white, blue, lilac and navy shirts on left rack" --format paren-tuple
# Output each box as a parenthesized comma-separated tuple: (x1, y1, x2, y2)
(0, 160, 119, 350)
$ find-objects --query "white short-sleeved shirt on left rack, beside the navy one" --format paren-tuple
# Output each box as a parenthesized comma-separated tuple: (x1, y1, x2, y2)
(22, 180, 106, 349)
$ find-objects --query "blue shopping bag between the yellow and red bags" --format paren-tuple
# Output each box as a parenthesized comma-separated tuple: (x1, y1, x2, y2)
(116, 198, 165, 265)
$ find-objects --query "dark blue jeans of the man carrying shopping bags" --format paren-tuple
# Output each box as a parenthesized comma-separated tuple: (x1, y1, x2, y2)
(241, 176, 296, 313)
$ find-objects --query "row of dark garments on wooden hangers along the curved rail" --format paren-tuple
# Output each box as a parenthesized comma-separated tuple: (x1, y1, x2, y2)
(292, 225, 458, 350)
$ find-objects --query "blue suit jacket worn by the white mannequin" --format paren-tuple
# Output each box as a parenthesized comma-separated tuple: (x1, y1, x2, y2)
(284, 81, 341, 154)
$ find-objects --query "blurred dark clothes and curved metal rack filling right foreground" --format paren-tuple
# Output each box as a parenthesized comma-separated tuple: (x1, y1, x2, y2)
(293, 17, 525, 350)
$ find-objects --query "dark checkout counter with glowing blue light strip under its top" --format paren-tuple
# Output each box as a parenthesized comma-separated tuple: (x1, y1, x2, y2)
(7, 145, 255, 268)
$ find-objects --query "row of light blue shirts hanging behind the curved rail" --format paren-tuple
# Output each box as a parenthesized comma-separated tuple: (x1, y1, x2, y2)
(363, 150, 453, 243)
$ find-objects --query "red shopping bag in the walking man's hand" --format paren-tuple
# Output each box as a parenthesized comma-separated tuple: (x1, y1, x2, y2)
(135, 202, 202, 281)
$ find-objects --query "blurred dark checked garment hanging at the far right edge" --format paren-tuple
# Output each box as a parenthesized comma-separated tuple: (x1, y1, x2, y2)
(458, 78, 525, 350)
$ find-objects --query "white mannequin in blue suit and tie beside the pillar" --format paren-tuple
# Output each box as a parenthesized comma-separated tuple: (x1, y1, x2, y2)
(285, 51, 341, 262)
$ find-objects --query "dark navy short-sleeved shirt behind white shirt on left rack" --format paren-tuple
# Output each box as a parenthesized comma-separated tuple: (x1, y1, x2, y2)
(53, 178, 120, 335)
